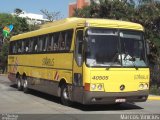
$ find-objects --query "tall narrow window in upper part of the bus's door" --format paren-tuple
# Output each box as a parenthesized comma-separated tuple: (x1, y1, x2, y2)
(75, 30, 83, 66)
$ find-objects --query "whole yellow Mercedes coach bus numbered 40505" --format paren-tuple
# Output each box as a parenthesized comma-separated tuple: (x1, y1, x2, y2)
(8, 18, 150, 105)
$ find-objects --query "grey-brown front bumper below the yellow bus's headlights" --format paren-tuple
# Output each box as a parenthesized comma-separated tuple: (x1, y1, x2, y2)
(83, 90, 149, 104)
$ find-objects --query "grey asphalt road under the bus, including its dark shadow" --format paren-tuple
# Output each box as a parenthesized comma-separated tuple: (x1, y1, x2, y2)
(0, 75, 160, 120)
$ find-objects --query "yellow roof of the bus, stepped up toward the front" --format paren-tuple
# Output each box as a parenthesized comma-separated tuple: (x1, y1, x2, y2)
(11, 17, 144, 41)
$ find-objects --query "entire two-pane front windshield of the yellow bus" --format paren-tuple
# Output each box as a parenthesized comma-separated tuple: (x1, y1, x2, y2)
(85, 28, 147, 67)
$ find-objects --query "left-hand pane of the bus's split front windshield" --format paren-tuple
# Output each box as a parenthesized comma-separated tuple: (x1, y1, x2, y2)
(86, 29, 121, 66)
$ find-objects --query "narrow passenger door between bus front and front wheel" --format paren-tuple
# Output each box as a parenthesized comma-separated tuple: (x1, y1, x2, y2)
(72, 29, 83, 102)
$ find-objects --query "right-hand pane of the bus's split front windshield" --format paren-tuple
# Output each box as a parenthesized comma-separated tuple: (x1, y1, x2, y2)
(119, 30, 146, 66)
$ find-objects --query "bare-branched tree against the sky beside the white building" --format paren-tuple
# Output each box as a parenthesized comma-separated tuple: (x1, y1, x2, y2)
(40, 9, 62, 21)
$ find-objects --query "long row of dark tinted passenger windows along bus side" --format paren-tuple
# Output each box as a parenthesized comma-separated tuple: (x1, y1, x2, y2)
(10, 30, 73, 54)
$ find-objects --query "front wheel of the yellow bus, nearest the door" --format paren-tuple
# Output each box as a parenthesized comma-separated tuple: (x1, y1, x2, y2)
(61, 84, 72, 106)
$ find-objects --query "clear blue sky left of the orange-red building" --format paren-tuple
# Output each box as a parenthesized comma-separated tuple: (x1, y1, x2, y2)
(0, 0, 76, 18)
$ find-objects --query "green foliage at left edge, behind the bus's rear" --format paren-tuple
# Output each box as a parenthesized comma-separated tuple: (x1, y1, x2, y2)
(0, 10, 39, 72)
